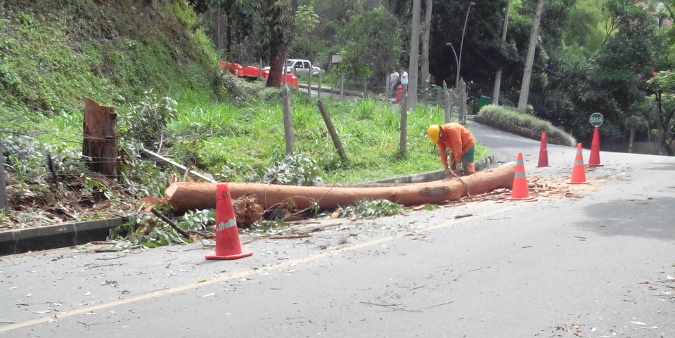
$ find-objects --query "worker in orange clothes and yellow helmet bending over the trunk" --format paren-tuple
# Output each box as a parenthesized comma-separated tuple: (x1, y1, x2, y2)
(427, 123, 476, 178)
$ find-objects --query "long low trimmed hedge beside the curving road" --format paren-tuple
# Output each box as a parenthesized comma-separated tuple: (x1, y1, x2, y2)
(475, 105, 577, 147)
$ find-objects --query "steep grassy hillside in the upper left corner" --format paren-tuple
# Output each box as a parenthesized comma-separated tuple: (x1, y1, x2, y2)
(0, 0, 216, 115)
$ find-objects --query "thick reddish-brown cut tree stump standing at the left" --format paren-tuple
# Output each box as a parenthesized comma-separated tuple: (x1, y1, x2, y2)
(82, 97, 119, 178)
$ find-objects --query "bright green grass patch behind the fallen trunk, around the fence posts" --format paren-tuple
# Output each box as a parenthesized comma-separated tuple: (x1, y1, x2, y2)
(164, 79, 489, 183)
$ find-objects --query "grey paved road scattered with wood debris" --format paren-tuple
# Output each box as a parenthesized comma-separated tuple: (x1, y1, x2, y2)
(0, 124, 675, 337)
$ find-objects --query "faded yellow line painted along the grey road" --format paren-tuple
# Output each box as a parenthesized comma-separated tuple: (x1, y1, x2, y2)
(0, 203, 525, 333)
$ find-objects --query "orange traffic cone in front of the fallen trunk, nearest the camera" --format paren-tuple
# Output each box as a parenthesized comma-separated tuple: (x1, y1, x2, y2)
(206, 183, 253, 259)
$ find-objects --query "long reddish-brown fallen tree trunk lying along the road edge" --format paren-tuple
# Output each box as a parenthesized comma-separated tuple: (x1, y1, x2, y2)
(164, 162, 515, 212)
